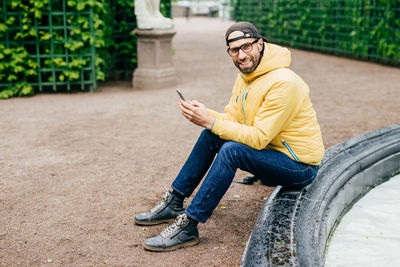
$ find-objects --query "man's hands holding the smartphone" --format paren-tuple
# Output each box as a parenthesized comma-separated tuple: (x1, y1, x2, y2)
(179, 99, 214, 130)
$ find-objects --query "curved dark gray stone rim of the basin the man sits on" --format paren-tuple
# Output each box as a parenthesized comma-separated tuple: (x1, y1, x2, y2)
(241, 124, 400, 267)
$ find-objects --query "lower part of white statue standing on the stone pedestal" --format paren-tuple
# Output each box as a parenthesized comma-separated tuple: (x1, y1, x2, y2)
(135, 0, 172, 30)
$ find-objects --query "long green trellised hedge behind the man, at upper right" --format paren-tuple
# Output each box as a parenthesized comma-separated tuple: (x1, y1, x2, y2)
(236, 0, 400, 66)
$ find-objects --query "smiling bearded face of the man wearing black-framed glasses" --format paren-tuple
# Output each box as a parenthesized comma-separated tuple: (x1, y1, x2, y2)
(228, 31, 263, 74)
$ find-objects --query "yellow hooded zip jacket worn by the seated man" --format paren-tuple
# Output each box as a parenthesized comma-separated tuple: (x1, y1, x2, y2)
(208, 43, 325, 165)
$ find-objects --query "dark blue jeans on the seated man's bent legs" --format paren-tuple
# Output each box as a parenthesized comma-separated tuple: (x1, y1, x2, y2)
(172, 130, 318, 223)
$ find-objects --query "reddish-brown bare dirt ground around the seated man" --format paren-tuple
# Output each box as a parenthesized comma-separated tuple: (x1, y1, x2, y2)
(0, 18, 400, 266)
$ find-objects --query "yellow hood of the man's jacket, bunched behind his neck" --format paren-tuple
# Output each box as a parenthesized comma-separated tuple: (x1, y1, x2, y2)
(242, 43, 292, 82)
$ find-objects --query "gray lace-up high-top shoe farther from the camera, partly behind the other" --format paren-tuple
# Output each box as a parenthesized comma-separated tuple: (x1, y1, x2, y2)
(135, 191, 185, 225)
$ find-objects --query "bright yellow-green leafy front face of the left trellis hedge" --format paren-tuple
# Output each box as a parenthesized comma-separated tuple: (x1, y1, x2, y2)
(0, 0, 105, 98)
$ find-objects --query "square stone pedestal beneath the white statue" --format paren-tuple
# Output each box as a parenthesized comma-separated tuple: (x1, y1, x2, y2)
(133, 30, 177, 89)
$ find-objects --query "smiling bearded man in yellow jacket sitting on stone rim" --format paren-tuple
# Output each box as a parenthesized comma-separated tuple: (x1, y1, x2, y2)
(135, 22, 324, 251)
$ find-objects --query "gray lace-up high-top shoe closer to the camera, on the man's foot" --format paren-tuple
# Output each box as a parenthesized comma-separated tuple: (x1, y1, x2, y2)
(143, 213, 200, 251)
